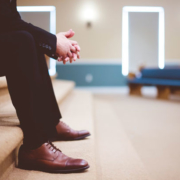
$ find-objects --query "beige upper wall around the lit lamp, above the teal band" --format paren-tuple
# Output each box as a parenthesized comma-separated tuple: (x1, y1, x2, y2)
(17, 0, 180, 61)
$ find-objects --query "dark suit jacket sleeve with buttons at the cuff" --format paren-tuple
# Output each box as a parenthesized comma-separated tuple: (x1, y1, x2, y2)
(0, 0, 58, 59)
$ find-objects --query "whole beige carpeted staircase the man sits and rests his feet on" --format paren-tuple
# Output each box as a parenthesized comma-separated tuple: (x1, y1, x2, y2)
(0, 80, 152, 180)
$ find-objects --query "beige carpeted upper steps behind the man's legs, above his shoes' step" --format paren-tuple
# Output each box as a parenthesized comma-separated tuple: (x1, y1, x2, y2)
(0, 80, 75, 179)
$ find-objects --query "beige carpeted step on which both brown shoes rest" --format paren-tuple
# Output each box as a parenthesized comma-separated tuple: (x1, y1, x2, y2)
(5, 90, 98, 180)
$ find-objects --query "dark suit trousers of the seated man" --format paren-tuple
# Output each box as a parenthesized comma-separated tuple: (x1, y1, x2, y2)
(0, 31, 61, 148)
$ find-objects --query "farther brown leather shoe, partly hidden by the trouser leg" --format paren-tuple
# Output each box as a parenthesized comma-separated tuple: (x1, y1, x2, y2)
(50, 121, 91, 141)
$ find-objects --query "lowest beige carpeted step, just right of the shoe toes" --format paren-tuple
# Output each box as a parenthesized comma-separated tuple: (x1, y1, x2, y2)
(94, 98, 150, 180)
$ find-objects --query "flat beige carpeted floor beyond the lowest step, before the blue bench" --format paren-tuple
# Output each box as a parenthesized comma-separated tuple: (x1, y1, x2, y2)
(95, 95, 180, 180)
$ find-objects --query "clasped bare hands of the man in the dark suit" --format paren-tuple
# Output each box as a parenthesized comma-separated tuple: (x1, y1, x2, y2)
(56, 29, 80, 64)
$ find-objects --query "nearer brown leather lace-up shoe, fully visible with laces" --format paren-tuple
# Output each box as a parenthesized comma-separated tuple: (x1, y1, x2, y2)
(18, 142, 89, 173)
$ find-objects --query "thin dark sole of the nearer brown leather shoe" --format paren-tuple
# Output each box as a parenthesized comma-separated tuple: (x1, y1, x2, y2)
(18, 165, 90, 174)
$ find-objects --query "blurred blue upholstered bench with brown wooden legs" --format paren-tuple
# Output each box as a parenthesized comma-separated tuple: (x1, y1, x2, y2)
(128, 67, 180, 99)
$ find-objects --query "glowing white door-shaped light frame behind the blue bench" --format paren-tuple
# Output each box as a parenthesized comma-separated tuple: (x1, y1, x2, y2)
(122, 6, 165, 76)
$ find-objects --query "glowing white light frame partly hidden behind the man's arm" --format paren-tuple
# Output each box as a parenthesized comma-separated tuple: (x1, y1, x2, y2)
(17, 6, 56, 76)
